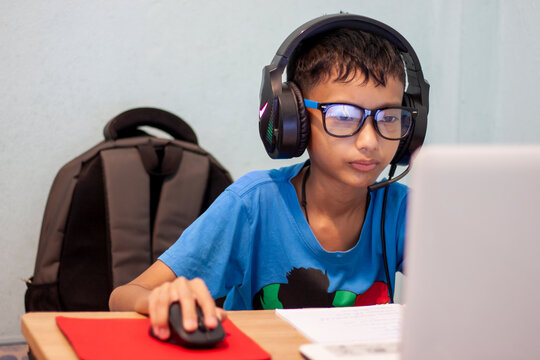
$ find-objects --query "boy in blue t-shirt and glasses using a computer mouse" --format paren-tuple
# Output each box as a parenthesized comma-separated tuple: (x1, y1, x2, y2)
(110, 12, 424, 339)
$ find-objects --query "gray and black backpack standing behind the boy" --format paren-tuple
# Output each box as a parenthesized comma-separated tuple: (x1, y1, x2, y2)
(25, 108, 232, 311)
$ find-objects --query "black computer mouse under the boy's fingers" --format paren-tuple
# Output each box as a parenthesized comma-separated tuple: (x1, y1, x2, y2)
(150, 302, 225, 349)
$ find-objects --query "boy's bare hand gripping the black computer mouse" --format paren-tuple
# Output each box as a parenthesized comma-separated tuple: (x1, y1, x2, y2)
(148, 276, 226, 340)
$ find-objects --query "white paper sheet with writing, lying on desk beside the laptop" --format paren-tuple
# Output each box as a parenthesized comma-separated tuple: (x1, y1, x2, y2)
(276, 304, 403, 344)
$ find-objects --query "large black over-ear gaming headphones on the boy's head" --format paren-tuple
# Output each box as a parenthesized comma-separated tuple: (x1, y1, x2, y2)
(259, 14, 429, 165)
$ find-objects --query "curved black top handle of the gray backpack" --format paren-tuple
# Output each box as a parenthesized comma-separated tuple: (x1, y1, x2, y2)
(103, 107, 198, 144)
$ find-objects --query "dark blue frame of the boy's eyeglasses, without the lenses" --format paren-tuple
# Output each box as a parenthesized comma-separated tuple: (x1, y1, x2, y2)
(304, 99, 418, 140)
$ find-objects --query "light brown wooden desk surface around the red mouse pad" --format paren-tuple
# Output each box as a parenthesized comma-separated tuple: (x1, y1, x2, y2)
(21, 310, 310, 360)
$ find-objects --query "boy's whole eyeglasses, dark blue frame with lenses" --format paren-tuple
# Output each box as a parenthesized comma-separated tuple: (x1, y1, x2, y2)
(304, 99, 418, 140)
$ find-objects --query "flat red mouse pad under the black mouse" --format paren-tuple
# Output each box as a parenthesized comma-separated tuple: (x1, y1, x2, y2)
(56, 316, 270, 360)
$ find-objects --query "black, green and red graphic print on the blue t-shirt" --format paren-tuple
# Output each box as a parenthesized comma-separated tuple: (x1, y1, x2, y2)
(253, 268, 390, 310)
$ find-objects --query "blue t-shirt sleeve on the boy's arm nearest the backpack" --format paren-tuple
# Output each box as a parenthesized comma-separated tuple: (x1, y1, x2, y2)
(159, 190, 251, 299)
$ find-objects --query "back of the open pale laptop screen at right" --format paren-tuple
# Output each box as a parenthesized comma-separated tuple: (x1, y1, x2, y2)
(402, 145, 540, 360)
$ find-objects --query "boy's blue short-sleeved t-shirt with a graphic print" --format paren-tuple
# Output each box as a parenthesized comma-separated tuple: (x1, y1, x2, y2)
(159, 164, 407, 310)
